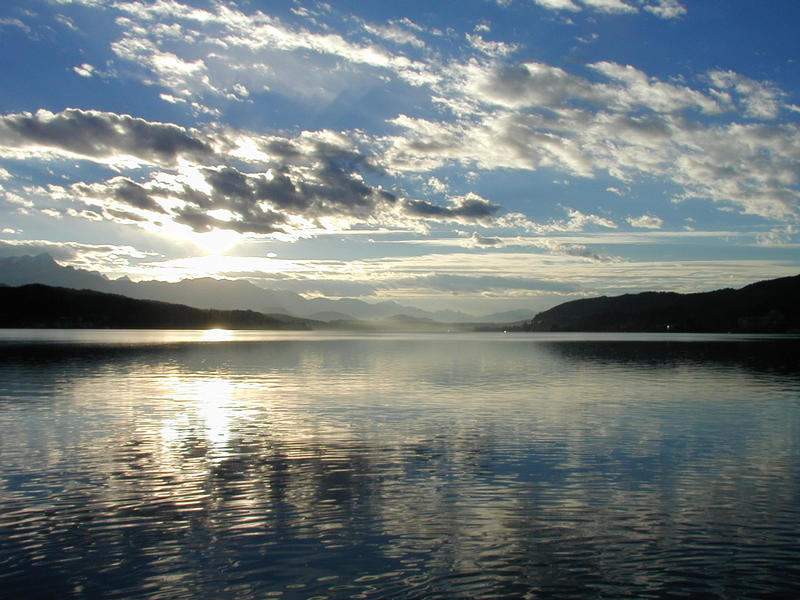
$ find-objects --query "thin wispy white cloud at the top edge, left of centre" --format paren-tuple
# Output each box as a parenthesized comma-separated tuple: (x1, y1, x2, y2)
(111, 0, 436, 104)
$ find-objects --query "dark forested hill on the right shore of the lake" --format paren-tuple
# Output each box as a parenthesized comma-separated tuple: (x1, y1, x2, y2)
(524, 275, 800, 333)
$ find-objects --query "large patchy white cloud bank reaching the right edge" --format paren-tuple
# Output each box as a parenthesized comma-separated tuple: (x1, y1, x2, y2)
(381, 55, 800, 220)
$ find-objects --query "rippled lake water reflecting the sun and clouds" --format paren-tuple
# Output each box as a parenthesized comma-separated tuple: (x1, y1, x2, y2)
(0, 330, 800, 599)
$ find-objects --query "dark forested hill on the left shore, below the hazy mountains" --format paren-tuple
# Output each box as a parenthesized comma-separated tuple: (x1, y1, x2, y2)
(0, 284, 313, 329)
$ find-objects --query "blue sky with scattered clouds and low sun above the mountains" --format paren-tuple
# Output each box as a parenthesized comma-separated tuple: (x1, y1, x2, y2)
(0, 0, 800, 314)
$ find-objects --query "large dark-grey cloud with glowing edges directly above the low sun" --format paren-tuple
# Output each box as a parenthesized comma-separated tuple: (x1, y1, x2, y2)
(42, 126, 500, 238)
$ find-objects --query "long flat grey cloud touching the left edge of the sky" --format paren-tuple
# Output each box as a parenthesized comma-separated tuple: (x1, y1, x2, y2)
(0, 108, 213, 166)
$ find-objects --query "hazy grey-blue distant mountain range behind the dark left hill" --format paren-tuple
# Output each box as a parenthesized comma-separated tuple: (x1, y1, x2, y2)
(0, 254, 534, 323)
